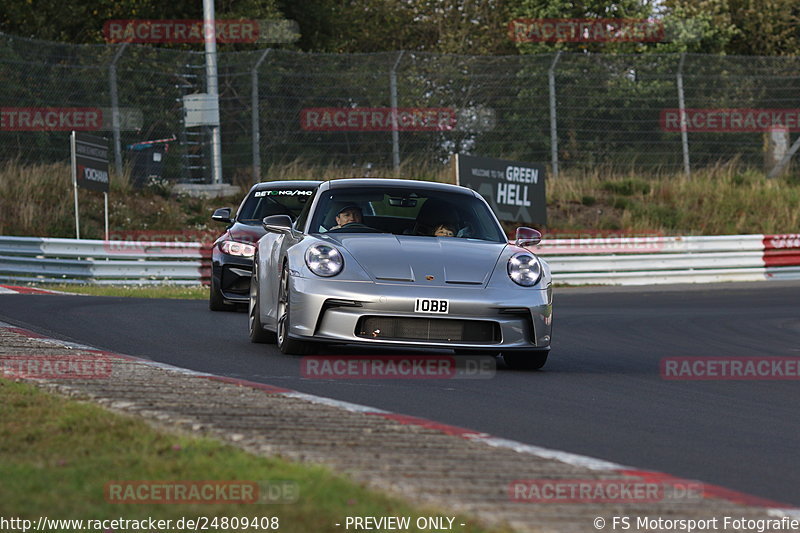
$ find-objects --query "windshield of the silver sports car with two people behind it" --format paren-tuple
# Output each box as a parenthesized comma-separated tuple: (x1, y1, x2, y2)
(310, 187, 506, 242)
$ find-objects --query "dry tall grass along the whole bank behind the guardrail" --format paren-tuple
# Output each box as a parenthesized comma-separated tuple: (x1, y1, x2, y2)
(0, 161, 800, 238)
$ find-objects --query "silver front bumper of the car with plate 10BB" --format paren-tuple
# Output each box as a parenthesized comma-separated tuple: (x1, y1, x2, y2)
(289, 276, 552, 351)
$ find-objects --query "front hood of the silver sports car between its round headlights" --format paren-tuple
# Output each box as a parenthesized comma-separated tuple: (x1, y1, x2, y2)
(327, 233, 507, 285)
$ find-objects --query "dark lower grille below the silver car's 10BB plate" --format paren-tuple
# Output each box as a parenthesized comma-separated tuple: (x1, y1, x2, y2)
(356, 316, 500, 343)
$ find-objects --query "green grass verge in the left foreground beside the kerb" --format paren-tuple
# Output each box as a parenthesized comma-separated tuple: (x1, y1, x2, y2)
(0, 379, 506, 533)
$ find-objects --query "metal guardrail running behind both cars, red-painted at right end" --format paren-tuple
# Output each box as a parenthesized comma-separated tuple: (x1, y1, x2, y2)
(0, 234, 800, 285)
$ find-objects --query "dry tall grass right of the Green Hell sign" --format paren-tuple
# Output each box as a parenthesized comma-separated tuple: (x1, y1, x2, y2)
(547, 163, 800, 235)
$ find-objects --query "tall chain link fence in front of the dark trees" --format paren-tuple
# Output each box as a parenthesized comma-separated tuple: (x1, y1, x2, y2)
(0, 34, 800, 182)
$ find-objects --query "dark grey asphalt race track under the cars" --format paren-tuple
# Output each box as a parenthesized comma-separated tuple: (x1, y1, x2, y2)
(0, 282, 800, 506)
